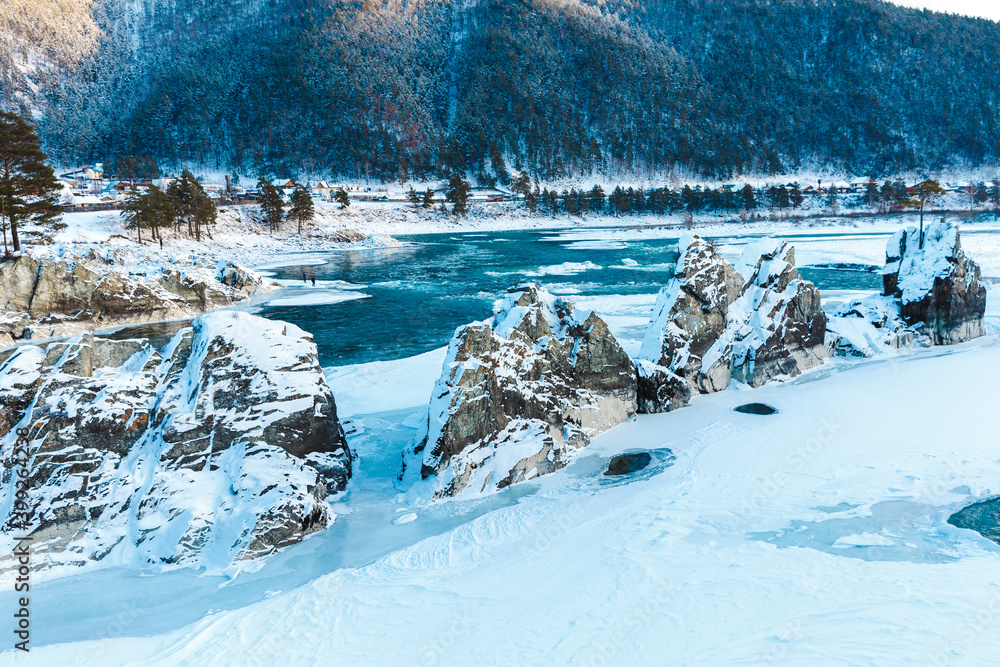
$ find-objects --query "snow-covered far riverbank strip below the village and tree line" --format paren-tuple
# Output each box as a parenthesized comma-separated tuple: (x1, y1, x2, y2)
(56, 202, 1000, 275)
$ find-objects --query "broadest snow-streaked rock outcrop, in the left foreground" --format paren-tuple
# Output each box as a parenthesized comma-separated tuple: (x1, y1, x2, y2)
(0, 312, 352, 572)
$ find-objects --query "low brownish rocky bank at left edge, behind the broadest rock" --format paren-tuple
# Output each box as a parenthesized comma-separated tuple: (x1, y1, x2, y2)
(0, 249, 266, 346)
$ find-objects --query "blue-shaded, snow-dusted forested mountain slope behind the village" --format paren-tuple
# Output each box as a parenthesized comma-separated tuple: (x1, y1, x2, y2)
(0, 0, 1000, 180)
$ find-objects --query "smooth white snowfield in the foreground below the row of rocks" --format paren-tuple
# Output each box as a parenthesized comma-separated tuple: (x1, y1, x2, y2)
(13, 326, 1000, 665)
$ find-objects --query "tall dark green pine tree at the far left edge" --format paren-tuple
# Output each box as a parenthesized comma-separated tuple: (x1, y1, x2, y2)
(0, 111, 65, 254)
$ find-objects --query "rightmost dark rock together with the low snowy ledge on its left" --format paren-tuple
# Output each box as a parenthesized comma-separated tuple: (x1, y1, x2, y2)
(830, 221, 986, 357)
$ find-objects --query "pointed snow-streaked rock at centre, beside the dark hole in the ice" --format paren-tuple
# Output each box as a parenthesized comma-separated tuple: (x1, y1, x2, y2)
(403, 284, 637, 498)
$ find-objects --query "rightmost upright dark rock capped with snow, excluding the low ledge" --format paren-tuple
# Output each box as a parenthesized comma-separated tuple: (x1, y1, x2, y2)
(882, 221, 986, 345)
